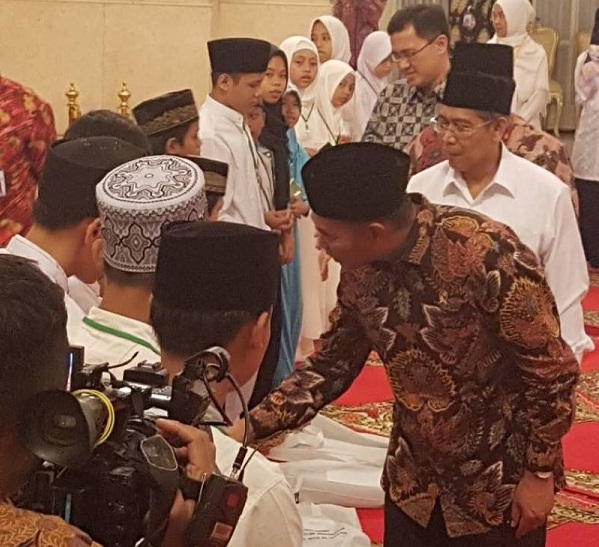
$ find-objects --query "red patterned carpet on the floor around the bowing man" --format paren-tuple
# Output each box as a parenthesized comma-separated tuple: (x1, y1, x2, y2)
(323, 284, 599, 547)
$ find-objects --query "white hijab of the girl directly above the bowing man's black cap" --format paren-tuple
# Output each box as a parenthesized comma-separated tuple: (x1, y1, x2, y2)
(312, 59, 354, 148)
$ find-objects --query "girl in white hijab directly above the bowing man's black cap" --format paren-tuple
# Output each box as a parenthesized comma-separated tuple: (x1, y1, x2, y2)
(311, 59, 356, 150)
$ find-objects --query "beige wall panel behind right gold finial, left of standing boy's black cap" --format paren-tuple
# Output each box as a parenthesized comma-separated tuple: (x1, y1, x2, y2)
(103, 0, 212, 115)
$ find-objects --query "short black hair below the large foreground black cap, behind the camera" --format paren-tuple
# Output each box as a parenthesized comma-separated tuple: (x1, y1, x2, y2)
(150, 298, 260, 358)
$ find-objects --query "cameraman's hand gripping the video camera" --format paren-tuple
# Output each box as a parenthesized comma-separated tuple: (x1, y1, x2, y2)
(156, 420, 216, 547)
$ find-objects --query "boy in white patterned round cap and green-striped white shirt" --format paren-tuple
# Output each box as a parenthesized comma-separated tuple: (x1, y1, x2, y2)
(71, 156, 207, 379)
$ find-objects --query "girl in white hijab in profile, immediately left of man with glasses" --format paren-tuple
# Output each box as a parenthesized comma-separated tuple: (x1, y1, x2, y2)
(352, 30, 393, 141)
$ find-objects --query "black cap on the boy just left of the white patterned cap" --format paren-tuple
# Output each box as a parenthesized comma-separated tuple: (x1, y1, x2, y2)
(37, 137, 147, 214)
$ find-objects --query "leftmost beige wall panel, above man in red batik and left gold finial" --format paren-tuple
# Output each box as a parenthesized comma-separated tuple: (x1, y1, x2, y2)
(0, 0, 104, 132)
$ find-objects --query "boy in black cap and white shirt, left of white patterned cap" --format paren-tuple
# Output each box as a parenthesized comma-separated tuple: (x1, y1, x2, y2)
(0, 137, 144, 338)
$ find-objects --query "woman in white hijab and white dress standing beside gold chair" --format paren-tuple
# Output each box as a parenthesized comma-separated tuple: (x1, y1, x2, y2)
(489, 0, 550, 129)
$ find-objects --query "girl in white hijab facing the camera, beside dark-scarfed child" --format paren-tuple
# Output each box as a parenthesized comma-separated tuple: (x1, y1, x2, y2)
(279, 36, 319, 149)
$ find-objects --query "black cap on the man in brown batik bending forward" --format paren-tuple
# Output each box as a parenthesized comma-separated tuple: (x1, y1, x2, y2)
(302, 146, 410, 222)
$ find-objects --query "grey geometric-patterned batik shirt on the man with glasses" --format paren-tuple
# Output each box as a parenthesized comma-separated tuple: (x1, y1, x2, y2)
(362, 79, 445, 151)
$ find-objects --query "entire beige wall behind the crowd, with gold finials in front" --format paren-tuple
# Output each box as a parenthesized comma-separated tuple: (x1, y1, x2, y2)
(0, 0, 330, 133)
